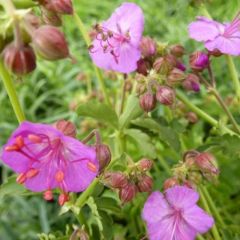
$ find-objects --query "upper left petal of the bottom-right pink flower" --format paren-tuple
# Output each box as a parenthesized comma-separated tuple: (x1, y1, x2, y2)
(142, 192, 170, 223)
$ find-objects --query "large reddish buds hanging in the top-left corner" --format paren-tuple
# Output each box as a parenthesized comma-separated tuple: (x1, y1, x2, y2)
(0, 0, 72, 76)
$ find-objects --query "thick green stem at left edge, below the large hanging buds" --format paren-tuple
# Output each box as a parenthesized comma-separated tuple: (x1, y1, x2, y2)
(0, 60, 25, 123)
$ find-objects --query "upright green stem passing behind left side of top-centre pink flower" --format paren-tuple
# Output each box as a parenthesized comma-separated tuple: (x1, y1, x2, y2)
(74, 12, 111, 105)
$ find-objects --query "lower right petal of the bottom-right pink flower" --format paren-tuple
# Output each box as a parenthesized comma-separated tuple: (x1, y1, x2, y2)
(183, 206, 214, 234)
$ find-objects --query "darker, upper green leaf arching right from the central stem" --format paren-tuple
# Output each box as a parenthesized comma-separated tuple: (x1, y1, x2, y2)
(132, 118, 181, 152)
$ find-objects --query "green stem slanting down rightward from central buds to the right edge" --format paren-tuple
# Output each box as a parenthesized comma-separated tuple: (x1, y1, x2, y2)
(177, 91, 236, 134)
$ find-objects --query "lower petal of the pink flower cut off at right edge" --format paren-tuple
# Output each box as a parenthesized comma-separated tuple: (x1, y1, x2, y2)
(205, 33, 240, 56)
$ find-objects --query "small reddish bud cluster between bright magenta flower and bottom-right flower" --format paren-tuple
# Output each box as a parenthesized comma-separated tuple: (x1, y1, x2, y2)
(103, 159, 153, 203)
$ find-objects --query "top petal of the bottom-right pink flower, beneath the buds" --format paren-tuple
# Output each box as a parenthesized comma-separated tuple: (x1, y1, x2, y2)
(166, 186, 199, 209)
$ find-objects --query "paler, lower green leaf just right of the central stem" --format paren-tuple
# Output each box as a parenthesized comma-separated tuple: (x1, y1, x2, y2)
(125, 128, 157, 158)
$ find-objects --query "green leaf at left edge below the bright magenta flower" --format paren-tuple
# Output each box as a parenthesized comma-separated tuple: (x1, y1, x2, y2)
(0, 176, 27, 199)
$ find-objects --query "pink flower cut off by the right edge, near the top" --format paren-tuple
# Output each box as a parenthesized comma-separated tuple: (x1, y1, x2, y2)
(188, 13, 240, 55)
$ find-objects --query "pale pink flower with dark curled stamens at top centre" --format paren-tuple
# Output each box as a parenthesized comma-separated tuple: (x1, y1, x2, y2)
(89, 3, 144, 73)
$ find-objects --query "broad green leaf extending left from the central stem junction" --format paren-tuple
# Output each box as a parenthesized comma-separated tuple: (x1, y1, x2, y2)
(77, 100, 118, 129)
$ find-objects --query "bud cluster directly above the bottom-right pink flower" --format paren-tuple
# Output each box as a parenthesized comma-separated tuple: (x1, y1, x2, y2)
(163, 150, 219, 190)
